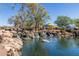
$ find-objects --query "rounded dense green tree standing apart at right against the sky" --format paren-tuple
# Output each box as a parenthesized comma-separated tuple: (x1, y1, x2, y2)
(55, 16, 72, 27)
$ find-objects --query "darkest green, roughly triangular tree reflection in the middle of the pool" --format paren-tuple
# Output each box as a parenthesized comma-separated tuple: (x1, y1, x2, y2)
(31, 41, 47, 56)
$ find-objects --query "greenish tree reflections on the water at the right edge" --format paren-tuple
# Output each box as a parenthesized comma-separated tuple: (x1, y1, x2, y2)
(59, 37, 79, 48)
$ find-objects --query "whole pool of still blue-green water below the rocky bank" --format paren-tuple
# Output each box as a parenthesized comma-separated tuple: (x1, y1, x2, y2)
(22, 37, 79, 56)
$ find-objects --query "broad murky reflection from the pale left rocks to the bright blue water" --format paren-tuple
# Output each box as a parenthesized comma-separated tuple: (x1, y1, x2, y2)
(22, 35, 47, 56)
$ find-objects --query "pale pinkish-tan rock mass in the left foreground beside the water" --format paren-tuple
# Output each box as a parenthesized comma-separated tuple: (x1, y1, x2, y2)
(0, 30, 23, 56)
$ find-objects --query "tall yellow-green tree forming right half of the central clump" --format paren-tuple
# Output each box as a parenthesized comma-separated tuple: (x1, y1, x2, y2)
(27, 3, 50, 30)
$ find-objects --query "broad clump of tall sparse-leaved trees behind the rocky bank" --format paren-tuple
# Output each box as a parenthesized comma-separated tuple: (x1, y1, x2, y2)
(9, 3, 49, 30)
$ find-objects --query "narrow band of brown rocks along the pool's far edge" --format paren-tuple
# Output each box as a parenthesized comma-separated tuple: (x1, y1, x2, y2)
(19, 30, 79, 39)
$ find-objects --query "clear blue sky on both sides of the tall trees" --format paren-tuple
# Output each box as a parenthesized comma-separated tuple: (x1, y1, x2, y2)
(0, 3, 79, 26)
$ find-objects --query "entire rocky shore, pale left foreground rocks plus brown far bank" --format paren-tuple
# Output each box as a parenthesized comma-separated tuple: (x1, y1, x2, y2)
(0, 29, 79, 56)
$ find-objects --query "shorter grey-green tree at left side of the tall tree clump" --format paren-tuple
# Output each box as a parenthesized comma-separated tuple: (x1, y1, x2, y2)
(8, 12, 26, 30)
